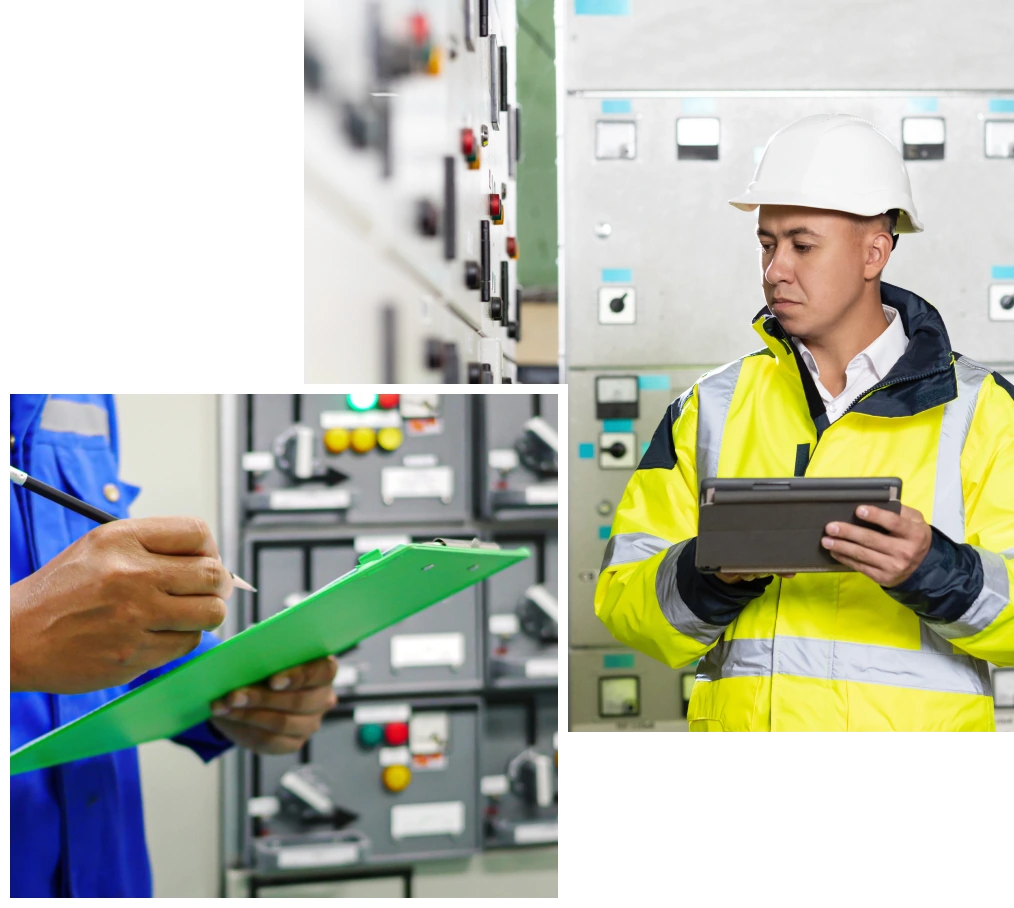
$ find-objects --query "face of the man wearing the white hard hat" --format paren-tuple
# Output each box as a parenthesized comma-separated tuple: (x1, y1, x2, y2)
(757, 205, 890, 338)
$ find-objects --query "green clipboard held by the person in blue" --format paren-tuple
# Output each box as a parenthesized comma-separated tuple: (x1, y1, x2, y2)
(10, 540, 530, 775)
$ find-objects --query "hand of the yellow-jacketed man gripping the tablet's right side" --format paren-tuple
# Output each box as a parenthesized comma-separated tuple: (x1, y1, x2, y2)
(822, 504, 933, 587)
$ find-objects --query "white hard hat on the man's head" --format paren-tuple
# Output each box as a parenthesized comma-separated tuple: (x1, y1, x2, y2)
(729, 114, 923, 233)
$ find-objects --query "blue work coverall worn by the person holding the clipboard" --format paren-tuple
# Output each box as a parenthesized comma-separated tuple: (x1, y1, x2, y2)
(10, 395, 231, 898)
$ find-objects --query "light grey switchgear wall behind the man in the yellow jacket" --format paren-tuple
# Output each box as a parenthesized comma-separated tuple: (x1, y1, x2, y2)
(557, 0, 1014, 731)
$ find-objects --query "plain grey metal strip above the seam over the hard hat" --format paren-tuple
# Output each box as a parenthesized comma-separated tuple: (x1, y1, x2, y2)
(557, 0, 1012, 89)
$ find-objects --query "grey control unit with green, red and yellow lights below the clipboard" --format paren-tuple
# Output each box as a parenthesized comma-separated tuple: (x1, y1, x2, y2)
(245, 698, 483, 874)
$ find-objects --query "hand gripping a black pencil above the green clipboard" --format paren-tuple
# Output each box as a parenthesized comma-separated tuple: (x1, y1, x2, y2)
(10, 517, 232, 694)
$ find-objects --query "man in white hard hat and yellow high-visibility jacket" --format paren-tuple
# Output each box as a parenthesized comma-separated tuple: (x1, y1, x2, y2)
(595, 115, 1014, 731)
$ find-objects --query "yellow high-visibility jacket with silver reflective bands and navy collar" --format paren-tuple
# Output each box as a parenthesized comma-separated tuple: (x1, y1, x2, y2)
(595, 284, 1014, 731)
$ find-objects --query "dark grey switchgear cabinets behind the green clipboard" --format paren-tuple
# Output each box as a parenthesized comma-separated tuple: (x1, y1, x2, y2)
(222, 391, 559, 885)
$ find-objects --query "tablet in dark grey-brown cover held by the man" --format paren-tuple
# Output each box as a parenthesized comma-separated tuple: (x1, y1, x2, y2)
(697, 477, 901, 574)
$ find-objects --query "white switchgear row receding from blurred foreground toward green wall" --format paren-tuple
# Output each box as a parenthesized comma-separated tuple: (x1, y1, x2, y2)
(303, 0, 522, 385)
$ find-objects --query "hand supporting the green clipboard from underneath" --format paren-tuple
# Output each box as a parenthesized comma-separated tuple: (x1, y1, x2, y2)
(211, 655, 338, 754)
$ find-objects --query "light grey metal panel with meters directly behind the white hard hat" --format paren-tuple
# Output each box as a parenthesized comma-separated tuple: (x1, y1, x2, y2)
(564, 91, 1014, 367)
